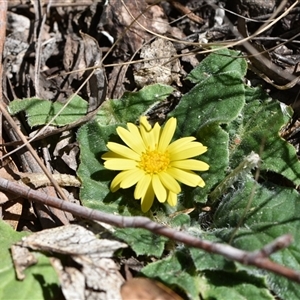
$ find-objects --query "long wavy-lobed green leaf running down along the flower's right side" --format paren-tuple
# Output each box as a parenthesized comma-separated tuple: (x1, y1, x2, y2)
(170, 50, 246, 206)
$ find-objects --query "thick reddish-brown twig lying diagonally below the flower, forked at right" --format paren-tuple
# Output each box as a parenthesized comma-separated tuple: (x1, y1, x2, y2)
(0, 178, 300, 283)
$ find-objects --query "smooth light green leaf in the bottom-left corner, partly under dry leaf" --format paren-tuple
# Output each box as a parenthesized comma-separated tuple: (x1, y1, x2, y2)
(0, 221, 60, 300)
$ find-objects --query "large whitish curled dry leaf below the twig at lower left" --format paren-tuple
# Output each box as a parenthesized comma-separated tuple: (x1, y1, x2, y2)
(14, 225, 127, 300)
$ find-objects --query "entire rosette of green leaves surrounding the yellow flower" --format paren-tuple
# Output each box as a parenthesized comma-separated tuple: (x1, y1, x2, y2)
(10, 50, 300, 300)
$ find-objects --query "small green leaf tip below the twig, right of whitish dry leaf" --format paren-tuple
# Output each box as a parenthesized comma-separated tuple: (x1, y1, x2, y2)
(114, 228, 167, 257)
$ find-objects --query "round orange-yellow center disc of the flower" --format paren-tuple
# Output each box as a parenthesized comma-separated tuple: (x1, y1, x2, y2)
(139, 150, 170, 174)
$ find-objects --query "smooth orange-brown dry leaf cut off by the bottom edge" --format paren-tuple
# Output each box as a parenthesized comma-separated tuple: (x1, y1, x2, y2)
(121, 278, 182, 300)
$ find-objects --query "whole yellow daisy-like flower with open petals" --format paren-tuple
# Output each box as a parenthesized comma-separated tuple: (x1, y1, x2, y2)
(102, 116, 209, 212)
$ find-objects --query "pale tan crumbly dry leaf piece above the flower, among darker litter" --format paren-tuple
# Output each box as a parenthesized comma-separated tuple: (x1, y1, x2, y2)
(134, 38, 182, 87)
